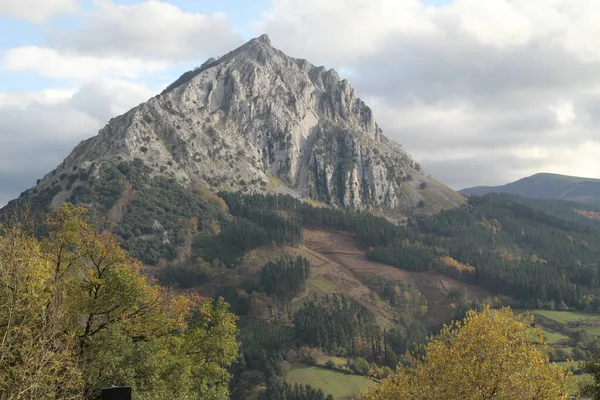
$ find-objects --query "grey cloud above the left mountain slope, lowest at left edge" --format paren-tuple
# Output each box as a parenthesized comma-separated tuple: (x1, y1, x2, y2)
(0, 79, 153, 206)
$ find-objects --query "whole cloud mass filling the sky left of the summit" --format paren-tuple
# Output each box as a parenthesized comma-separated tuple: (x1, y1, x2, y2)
(0, 0, 243, 204)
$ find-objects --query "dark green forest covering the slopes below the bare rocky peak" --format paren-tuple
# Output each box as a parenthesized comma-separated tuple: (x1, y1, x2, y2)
(4, 162, 600, 399)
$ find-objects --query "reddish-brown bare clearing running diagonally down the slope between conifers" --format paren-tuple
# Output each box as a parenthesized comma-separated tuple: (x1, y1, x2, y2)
(304, 229, 491, 324)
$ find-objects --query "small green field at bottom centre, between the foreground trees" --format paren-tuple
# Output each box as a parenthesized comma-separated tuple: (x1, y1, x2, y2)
(285, 364, 367, 400)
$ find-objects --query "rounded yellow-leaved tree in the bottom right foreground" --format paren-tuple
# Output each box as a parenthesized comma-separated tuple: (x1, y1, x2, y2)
(361, 307, 571, 400)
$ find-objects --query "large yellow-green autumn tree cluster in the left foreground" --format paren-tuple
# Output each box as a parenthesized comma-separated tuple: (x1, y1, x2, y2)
(0, 205, 238, 400)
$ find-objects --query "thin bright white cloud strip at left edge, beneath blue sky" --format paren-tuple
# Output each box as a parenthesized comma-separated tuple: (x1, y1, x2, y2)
(1, 46, 170, 79)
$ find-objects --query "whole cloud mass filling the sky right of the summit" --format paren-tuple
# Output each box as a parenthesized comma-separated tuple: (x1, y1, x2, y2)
(254, 0, 600, 189)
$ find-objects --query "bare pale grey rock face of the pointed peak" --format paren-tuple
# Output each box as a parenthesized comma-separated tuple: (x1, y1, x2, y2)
(31, 35, 462, 216)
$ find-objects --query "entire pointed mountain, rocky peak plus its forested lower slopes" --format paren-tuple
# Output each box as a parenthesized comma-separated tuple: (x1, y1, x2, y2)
(0, 36, 600, 399)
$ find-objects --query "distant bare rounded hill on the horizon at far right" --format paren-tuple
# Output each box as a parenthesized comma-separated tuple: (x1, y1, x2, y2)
(459, 173, 600, 205)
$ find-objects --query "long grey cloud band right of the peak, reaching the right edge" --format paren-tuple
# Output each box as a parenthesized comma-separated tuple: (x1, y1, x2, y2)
(352, 35, 600, 107)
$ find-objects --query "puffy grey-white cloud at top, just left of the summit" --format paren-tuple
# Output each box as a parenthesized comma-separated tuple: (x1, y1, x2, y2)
(49, 0, 243, 62)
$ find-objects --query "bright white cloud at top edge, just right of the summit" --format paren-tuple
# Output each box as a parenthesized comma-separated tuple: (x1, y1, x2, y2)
(254, 0, 436, 65)
